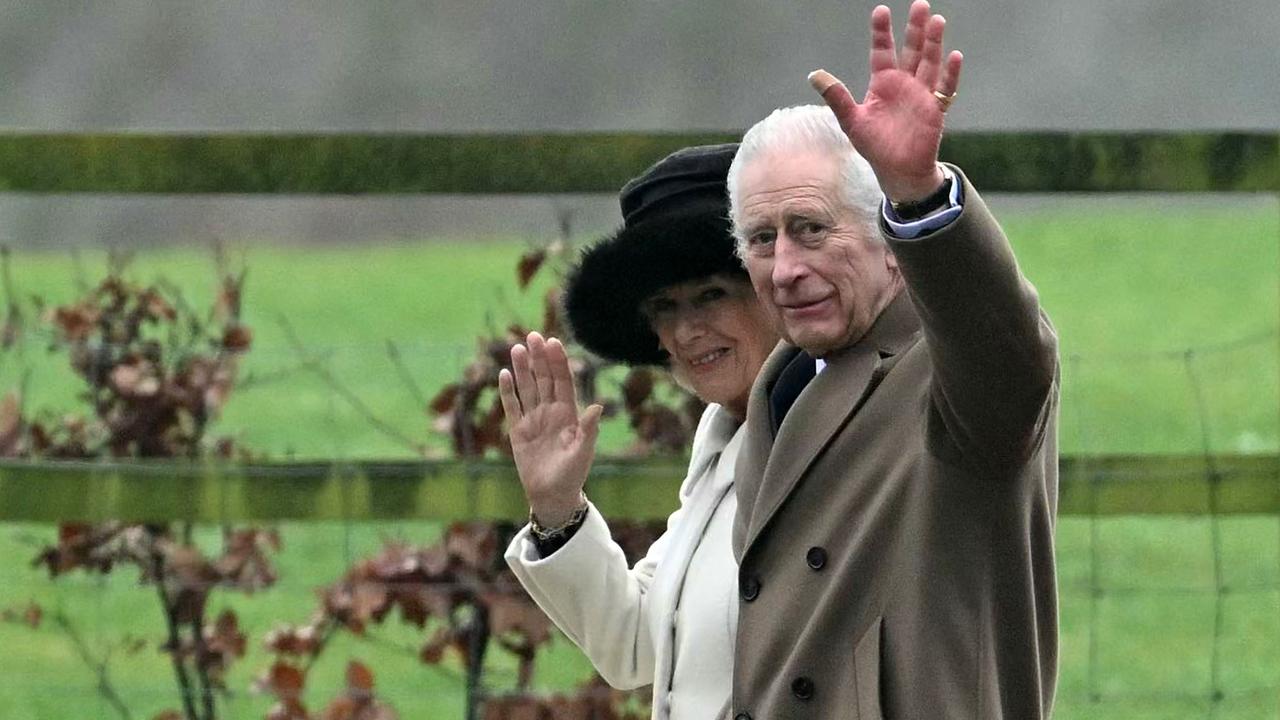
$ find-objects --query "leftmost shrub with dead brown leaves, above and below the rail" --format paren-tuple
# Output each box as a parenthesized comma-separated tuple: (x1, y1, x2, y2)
(0, 254, 280, 720)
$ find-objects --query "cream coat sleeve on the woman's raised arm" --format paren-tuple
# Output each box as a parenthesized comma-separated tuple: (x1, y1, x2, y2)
(506, 497, 682, 689)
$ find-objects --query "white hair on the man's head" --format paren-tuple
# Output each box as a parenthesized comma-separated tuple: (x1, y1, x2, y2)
(728, 105, 883, 258)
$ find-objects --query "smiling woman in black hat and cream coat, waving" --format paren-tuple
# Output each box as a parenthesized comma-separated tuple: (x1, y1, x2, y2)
(499, 145, 777, 720)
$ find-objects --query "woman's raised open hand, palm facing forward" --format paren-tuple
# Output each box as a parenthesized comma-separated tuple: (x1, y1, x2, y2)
(498, 333, 603, 525)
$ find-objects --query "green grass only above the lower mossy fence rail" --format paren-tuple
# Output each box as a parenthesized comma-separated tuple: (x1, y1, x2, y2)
(0, 196, 1280, 457)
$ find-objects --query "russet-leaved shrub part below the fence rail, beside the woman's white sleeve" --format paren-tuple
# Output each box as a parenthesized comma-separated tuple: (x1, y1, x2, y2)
(259, 523, 662, 720)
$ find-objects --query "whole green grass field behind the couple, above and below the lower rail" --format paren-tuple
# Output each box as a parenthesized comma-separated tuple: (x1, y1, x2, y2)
(0, 193, 1280, 720)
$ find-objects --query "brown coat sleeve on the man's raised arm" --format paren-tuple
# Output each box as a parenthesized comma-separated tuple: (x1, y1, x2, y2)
(887, 168, 1059, 475)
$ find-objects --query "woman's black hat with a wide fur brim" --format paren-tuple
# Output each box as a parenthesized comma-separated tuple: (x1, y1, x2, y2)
(564, 142, 746, 365)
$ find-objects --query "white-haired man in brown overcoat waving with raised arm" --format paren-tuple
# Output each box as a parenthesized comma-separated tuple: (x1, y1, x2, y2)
(726, 0, 1059, 720)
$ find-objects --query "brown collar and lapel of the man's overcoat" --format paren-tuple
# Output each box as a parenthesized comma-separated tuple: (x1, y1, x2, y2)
(735, 291, 920, 552)
